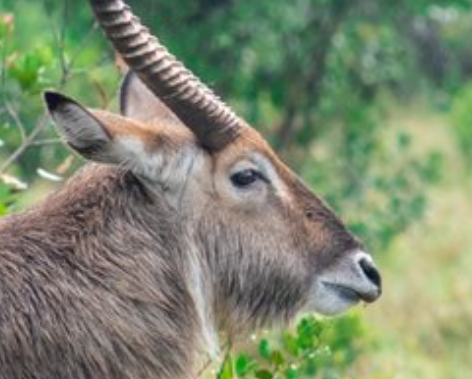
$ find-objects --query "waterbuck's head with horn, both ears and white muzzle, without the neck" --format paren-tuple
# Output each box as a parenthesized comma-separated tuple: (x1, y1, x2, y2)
(45, 0, 381, 332)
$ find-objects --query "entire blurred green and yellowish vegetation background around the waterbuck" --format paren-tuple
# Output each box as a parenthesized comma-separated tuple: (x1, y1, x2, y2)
(0, 0, 472, 379)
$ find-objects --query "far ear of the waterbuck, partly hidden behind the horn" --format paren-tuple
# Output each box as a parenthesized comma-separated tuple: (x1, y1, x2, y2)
(120, 70, 183, 126)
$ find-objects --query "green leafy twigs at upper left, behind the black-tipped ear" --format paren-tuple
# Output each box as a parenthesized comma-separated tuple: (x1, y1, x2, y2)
(0, 2, 118, 183)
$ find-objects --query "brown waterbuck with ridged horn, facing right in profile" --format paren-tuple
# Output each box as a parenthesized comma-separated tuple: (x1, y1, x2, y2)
(0, 0, 381, 379)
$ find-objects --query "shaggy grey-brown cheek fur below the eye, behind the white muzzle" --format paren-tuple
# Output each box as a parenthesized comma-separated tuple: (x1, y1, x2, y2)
(196, 211, 311, 327)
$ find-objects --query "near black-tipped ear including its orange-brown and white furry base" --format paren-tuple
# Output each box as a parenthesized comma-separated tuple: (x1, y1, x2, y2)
(44, 92, 196, 184)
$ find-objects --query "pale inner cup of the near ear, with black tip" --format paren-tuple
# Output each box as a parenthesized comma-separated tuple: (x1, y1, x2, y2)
(44, 91, 113, 163)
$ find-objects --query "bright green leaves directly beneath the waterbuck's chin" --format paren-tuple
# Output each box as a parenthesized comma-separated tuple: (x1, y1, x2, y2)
(211, 314, 366, 379)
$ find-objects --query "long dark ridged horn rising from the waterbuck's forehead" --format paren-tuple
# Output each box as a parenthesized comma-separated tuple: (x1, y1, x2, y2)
(89, 0, 242, 151)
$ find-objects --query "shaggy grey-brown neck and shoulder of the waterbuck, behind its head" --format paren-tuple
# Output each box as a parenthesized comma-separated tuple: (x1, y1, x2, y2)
(0, 166, 200, 379)
